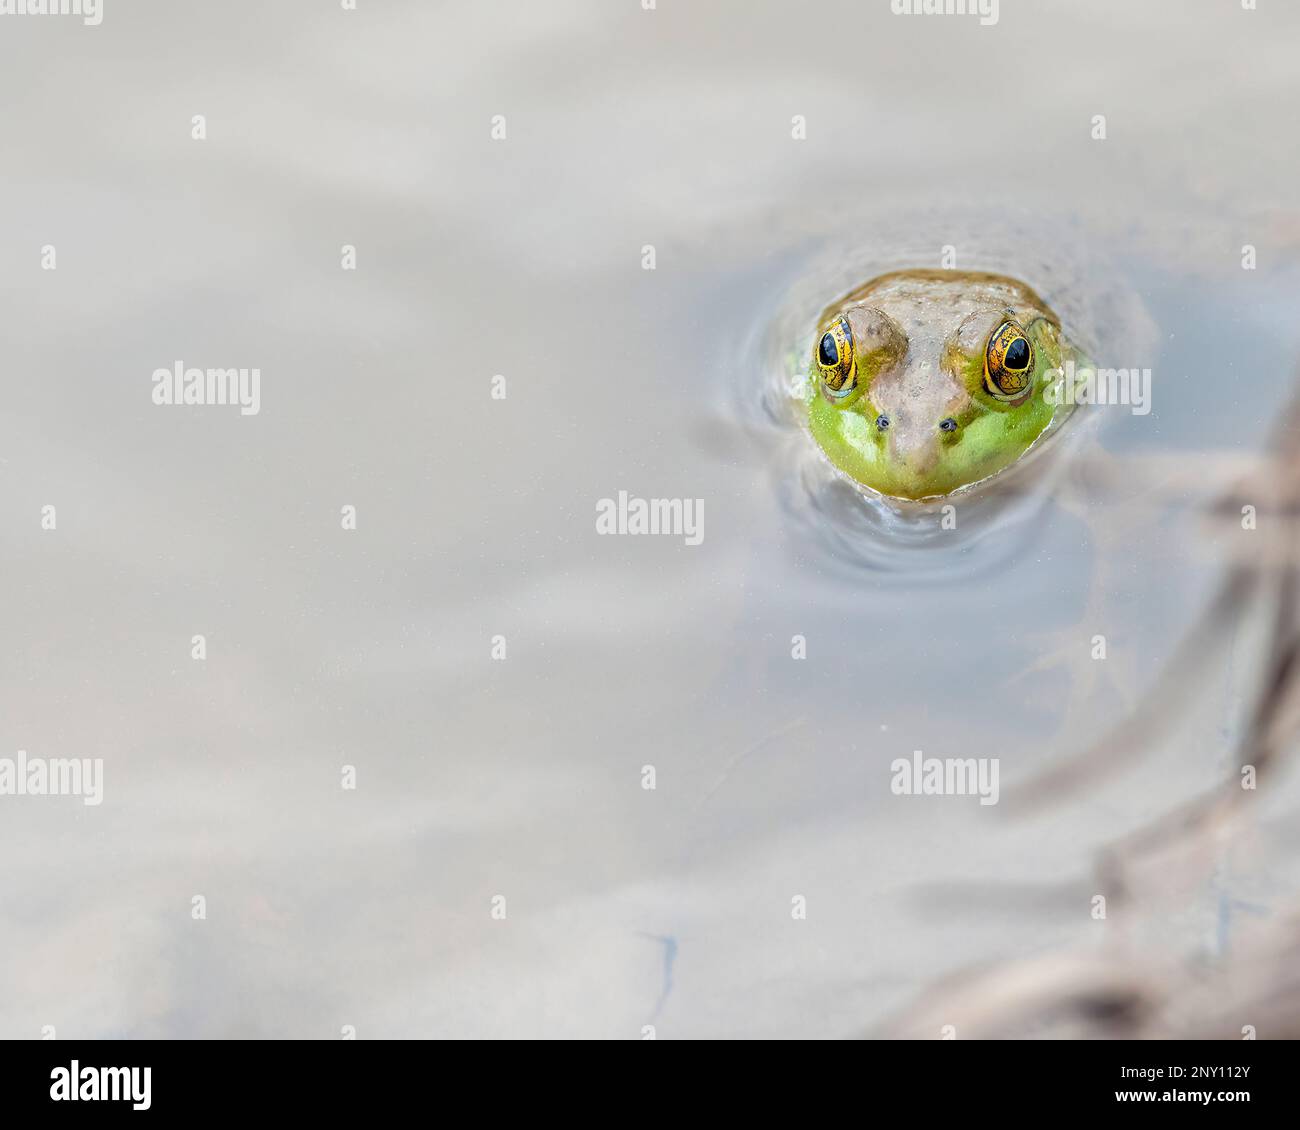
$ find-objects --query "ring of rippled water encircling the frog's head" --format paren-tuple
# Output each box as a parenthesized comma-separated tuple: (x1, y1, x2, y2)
(727, 210, 1152, 584)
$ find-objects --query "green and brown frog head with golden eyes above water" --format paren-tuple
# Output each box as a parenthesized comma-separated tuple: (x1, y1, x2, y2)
(805, 269, 1088, 501)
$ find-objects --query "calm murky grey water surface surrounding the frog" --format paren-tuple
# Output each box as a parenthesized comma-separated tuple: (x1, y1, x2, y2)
(0, 0, 1300, 1038)
